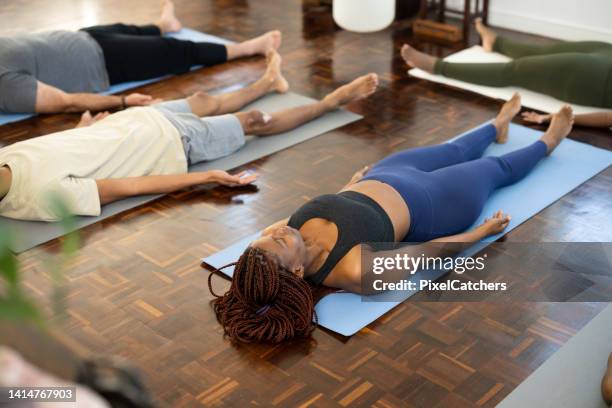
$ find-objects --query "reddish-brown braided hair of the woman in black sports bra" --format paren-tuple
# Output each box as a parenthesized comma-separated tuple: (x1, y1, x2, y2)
(208, 247, 316, 343)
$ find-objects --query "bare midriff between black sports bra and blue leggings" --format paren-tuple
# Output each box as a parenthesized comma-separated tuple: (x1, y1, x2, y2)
(346, 180, 410, 241)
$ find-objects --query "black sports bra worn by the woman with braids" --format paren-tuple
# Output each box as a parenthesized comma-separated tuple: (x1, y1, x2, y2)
(287, 191, 395, 285)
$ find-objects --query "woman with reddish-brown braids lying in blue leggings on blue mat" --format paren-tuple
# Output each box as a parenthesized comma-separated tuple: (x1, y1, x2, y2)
(208, 94, 572, 342)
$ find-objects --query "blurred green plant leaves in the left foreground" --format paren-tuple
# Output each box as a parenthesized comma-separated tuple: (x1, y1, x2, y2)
(0, 195, 80, 326)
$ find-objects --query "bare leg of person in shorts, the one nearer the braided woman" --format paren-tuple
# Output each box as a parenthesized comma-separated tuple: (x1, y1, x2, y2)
(236, 74, 378, 136)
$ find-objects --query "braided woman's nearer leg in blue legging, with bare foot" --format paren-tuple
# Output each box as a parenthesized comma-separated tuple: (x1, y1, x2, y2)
(423, 106, 572, 239)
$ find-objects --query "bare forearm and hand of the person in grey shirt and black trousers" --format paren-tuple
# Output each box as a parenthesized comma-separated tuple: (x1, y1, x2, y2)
(36, 81, 159, 113)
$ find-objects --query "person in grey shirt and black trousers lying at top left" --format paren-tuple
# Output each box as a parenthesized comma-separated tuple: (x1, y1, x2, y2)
(0, 0, 281, 113)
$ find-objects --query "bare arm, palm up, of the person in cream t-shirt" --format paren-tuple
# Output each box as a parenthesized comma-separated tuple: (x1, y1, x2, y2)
(96, 170, 257, 205)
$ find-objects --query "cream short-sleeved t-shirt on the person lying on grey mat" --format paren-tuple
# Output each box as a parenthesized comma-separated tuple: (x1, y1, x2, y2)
(0, 107, 187, 221)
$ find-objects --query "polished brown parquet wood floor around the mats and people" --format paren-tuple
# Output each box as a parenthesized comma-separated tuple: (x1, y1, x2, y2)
(0, 0, 612, 408)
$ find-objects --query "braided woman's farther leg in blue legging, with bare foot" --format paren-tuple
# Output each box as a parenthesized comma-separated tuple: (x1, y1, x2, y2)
(369, 94, 521, 174)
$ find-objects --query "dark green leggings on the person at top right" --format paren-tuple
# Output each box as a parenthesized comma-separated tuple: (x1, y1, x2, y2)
(434, 36, 612, 108)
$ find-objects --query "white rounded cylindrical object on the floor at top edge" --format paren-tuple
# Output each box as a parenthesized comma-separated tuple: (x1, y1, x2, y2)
(333, 0, 395, 33)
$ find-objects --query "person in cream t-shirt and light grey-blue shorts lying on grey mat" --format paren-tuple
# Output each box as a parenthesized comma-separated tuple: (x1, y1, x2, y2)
(0, 51, 378, 221)
